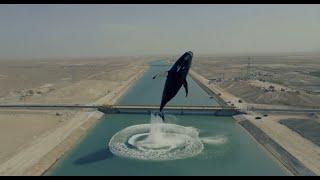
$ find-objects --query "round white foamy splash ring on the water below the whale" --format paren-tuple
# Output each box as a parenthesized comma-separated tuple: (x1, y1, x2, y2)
(108, 124, 204, 161)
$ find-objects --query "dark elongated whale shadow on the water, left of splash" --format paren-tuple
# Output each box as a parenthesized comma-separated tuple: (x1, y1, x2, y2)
(74, 148, 113, 165)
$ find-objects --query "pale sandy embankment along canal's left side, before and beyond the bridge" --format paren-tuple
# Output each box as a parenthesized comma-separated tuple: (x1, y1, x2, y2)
(0, 67, 147, 176)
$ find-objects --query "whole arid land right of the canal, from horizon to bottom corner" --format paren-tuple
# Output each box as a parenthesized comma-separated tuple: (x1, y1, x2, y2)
(193, 54, 320, 175)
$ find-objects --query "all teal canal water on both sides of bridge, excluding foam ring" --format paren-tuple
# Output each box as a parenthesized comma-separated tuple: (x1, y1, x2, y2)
(46, 61, 289, 176)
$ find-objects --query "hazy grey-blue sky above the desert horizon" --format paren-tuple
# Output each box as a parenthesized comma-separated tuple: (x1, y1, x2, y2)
(0, 4, 320, 58)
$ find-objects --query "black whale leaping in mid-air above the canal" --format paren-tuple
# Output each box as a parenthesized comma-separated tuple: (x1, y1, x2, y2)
(153, 51, 193, 121)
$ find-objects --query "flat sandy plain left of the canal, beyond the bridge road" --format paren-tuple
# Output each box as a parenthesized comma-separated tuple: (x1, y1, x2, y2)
(0, 59, 150, 104)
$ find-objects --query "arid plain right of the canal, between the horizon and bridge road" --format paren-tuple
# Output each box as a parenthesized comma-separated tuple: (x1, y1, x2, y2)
(193, 55, 320, 107)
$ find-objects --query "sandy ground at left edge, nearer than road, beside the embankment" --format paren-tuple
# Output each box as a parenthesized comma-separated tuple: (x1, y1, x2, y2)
(0, 110, 74, 162)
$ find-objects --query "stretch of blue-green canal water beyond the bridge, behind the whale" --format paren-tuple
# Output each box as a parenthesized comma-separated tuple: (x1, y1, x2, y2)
(118, 61, 219, 106)
